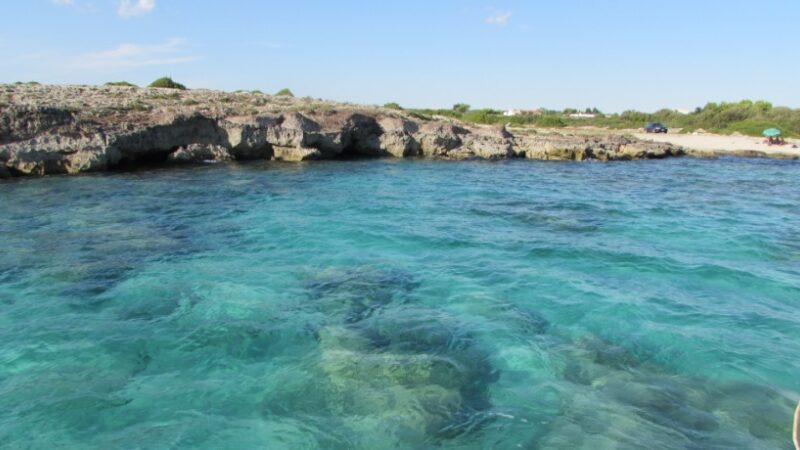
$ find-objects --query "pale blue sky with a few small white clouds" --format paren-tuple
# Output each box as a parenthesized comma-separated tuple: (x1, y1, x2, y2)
(0, 0, 800, 112)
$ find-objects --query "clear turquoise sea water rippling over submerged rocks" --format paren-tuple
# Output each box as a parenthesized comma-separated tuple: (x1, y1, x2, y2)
(0, 159, 800, 449)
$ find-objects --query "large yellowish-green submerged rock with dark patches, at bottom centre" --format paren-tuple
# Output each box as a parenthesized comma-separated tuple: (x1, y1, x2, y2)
(267, 268, 497, 446)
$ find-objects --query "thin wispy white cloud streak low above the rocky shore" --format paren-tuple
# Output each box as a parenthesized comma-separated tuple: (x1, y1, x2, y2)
(72, 38, 197, 69)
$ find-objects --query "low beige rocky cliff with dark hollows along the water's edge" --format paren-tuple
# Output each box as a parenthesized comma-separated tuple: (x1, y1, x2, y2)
(0, 84, 792, 178)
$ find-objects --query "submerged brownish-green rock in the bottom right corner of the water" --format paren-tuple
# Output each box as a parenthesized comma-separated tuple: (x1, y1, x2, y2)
(552, 335, 792, 449)
